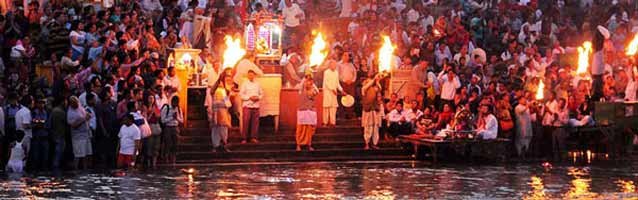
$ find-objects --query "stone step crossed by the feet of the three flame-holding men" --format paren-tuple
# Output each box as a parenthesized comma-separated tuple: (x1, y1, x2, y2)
(178, 139, 397, 152)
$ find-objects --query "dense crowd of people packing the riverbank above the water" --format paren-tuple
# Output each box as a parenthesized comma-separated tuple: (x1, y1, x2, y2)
(0, 0, 638, 171)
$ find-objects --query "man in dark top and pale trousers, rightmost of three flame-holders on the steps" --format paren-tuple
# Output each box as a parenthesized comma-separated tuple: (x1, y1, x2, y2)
(361, 74, 383, 150)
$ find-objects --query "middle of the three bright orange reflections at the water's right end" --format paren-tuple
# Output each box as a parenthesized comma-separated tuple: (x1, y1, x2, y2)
(565, 167, 599, 199)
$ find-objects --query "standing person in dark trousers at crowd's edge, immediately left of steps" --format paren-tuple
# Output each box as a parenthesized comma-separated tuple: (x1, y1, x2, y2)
(160, 96, 184, 164)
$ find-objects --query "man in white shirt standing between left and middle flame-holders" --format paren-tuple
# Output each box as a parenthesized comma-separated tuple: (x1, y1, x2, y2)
(239, 70, 264, 144)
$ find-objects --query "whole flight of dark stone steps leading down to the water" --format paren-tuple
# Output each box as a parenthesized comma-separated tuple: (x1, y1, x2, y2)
(177, 120, 411, 164)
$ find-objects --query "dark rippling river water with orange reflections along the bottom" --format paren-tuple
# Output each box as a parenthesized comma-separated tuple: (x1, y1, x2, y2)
(0, 161, 638, 199)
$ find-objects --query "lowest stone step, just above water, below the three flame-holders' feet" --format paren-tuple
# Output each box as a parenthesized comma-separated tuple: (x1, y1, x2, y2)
(177, 147, 410, 162)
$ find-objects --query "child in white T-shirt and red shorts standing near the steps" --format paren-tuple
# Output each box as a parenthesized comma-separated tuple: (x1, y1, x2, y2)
(117, 114, 142, 168)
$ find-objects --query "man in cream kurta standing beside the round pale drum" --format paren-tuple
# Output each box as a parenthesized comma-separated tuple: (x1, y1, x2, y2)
(322, 61, 343, 126)
